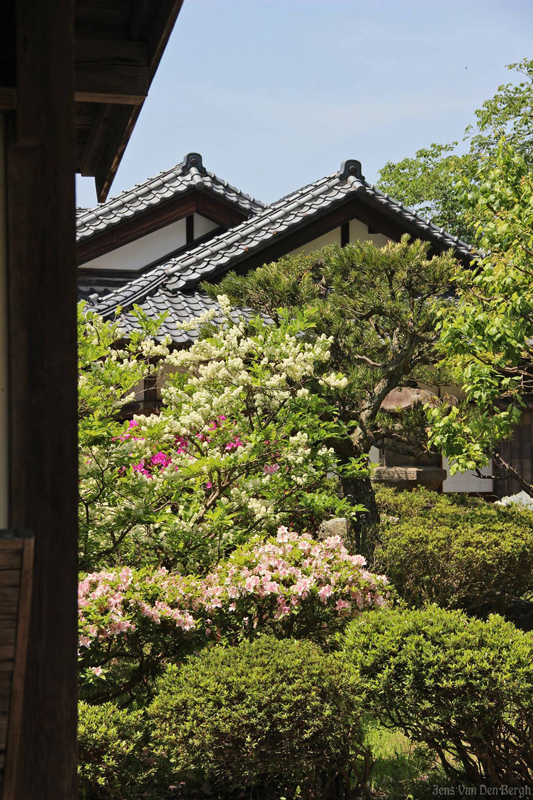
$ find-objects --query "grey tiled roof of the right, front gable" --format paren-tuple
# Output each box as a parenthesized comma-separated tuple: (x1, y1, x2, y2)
(94, 160, 474, 335)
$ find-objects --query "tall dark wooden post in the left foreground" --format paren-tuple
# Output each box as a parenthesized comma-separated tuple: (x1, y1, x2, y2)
(6, 0, 77, 800)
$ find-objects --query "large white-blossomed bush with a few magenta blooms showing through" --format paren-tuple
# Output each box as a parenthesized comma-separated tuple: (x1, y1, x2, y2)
(80, 298, 365, 572)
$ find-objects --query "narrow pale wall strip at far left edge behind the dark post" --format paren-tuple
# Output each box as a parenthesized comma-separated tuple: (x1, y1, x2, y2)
(0, 114, 9, 528)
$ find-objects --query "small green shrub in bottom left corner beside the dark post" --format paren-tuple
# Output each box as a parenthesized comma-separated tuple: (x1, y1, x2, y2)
(78, 702, 168, 800)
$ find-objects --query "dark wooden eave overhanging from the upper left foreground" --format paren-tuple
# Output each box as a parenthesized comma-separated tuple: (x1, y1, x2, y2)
(0, 0, 183, 202)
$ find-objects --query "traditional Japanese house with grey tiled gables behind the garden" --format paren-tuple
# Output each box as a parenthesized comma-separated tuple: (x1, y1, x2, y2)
(77, 153, 507, 495)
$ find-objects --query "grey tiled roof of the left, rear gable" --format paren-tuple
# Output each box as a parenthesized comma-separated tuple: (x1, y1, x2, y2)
(76, 153, 265, 241)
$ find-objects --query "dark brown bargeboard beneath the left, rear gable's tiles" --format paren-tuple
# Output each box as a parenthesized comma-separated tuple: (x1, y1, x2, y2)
(77, 189, 247, 265)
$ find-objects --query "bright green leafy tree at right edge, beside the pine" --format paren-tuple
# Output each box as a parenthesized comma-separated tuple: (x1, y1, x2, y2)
(429, 140, 533, 496)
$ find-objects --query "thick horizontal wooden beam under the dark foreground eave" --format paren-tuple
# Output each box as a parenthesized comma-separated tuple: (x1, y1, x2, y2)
(76, 38, 150, 105)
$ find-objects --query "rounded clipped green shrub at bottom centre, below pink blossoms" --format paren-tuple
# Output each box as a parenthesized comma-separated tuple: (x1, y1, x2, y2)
(150, 636, 370, 800)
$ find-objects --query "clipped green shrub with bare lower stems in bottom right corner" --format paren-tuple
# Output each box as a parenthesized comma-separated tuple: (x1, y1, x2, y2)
(345, 606, 533, 787)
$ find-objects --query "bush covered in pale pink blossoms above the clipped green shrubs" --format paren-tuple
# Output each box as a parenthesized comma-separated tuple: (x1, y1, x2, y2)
(79, 527, 387, 702)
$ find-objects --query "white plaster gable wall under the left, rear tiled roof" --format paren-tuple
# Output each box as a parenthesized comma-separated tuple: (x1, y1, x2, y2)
(82, 214, 218, 270)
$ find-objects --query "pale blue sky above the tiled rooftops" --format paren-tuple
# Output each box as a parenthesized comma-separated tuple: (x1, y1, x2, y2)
(77, 0, 533, 207)
